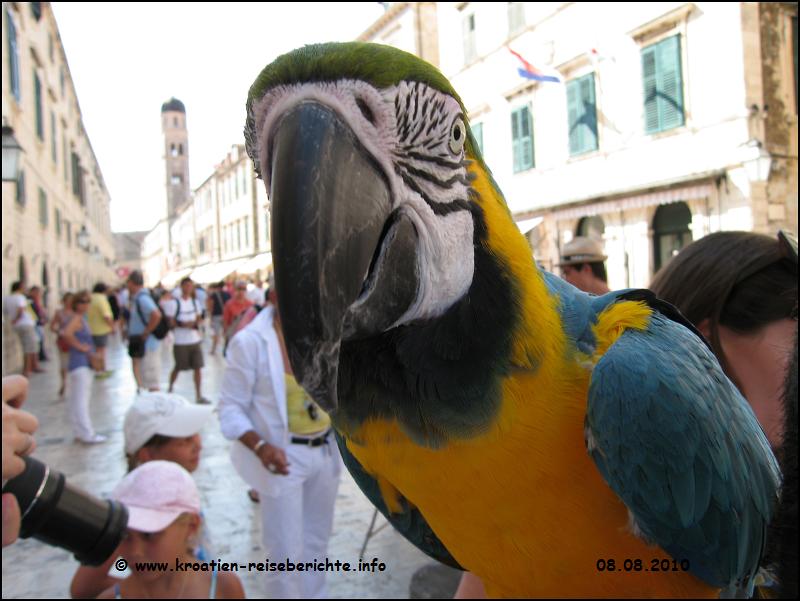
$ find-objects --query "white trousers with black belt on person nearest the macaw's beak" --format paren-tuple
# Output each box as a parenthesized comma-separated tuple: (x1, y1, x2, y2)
(261, 436, 341, 599)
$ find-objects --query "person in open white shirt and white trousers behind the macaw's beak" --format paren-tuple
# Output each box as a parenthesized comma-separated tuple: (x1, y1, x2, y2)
(219, 287, 342, 599)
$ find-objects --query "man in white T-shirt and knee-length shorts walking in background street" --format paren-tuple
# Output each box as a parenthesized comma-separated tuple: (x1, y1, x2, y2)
(165, 278, 211, 405)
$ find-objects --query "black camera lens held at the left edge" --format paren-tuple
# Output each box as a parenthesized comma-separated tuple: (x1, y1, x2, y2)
(3, 457, 128, 566)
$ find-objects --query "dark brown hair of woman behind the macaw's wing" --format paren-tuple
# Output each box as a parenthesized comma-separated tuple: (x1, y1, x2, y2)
(650, 232, 797, 377)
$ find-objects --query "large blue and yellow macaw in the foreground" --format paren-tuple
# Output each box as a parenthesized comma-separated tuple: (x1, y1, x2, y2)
(245, 43, 779, 597)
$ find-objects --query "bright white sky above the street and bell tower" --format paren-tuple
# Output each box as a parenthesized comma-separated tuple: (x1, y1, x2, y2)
(52, 2, 383, 231)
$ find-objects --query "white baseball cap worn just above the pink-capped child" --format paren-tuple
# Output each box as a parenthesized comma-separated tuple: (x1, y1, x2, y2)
(122, 392, 213, 455)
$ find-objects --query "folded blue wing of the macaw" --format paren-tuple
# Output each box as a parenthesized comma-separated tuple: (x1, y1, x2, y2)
(586, 312, 780, 587)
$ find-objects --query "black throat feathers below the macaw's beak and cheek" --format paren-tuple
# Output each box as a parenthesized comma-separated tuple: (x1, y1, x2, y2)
(335, 203, 520, 448)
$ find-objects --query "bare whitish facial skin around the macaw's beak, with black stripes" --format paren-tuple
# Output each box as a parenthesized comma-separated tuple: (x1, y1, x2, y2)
(253, 80, 474, 327)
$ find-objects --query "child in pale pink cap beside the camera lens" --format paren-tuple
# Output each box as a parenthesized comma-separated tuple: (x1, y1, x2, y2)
(98, 460, 244, 599)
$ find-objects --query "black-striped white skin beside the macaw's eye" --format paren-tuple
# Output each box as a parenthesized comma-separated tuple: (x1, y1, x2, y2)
(394, 82, 470, 215)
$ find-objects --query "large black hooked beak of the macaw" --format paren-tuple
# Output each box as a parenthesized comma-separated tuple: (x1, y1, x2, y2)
(268, 101, 419, 412)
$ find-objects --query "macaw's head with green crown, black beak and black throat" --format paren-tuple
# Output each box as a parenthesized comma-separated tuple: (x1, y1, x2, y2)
(245, 43, 533, 441)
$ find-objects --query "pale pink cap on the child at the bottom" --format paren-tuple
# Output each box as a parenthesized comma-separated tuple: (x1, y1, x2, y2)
(111, 461, 200, 532)
